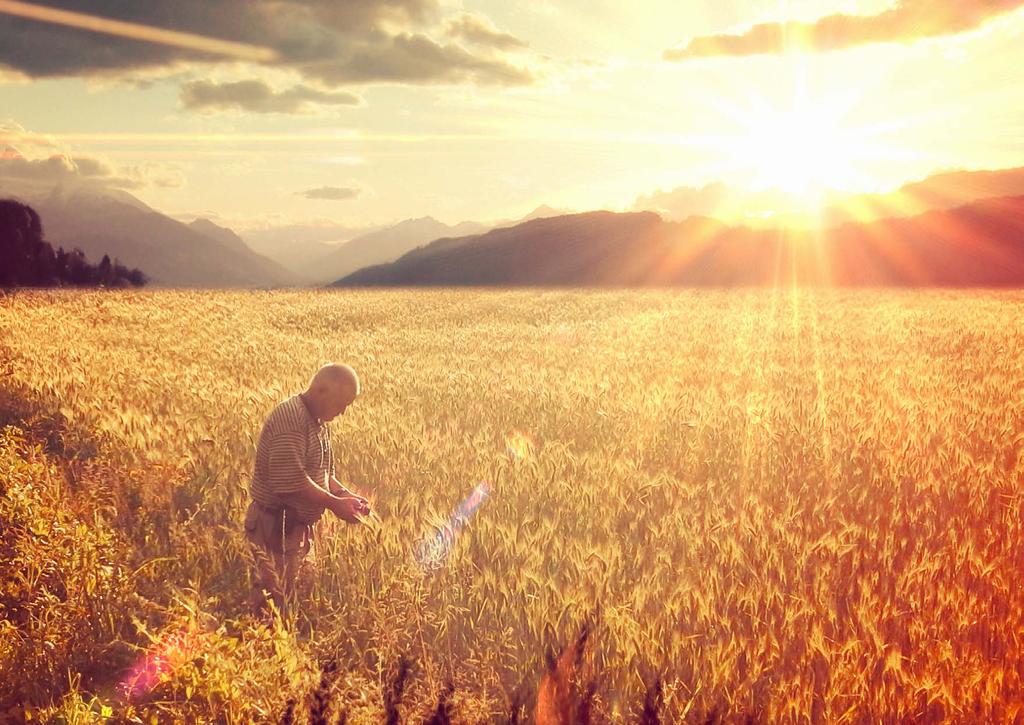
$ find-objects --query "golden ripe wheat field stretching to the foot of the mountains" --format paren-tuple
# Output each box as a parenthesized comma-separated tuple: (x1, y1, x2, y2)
(0, 289, 1024, 723)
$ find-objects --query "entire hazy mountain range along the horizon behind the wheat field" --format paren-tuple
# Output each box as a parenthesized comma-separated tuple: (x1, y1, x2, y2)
(6, 169, 1024, 287)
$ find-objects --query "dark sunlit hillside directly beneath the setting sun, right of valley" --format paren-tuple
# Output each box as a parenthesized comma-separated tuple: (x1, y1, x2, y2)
(336, 197, 1024, 287)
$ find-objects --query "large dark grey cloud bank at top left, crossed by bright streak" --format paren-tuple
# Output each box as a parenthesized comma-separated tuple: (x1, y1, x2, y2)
(0, 0, 535, 87)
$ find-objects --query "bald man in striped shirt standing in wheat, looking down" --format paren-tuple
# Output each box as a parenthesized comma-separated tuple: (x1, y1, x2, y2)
(245, 364, 370, 614)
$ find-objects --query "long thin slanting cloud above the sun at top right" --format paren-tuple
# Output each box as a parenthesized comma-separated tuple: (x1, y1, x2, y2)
(663, 0, 1024, 60)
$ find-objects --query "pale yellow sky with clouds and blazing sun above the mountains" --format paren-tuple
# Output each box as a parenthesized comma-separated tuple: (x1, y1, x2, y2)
(0, 0, 1024, 231)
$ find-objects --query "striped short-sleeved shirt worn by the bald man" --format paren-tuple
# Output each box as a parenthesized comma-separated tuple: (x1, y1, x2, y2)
(249, 395, 334, 523)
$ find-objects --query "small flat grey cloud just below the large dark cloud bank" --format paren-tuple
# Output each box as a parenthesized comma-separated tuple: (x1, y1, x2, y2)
(180, 80, 361, 114)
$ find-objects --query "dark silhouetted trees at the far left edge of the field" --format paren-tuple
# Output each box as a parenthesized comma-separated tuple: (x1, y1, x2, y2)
(0, 199, 148, 288)
